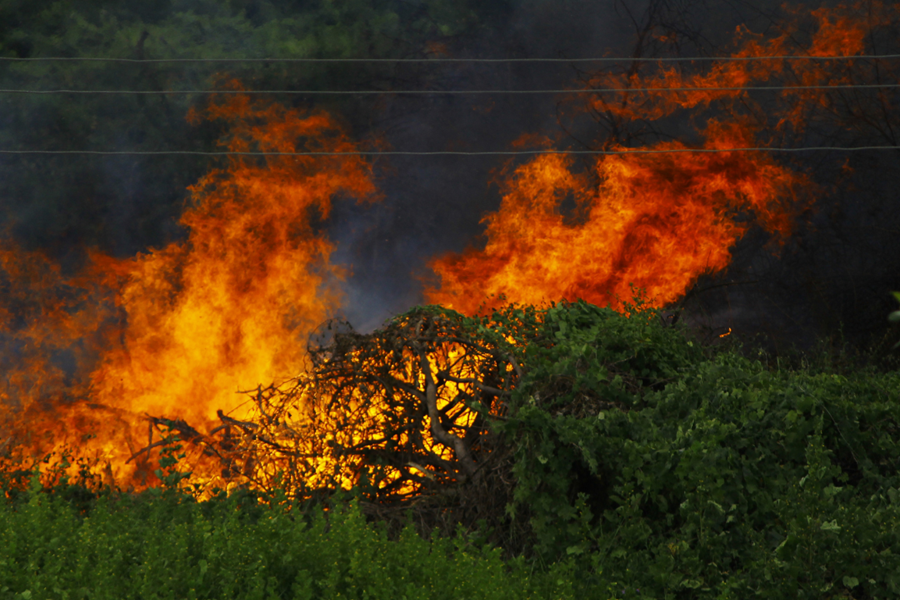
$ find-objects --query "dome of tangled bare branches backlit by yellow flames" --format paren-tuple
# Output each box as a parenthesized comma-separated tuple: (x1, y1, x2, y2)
(200, 307, 536, 502)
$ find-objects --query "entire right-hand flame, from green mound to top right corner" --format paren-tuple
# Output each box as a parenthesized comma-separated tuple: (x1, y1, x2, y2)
(426, 2, 898, 314)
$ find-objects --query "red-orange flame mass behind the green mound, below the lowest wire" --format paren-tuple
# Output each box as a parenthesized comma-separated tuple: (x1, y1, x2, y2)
(428, 123, 806, 314)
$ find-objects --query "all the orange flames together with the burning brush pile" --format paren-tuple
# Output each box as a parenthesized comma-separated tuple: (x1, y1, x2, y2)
(0, 4, 896, 510)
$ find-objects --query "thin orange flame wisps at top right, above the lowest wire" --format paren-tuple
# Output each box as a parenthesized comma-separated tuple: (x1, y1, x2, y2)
(587, 1, 900, 131)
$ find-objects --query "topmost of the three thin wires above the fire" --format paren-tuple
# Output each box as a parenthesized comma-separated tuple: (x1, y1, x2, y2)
(0, 54, 900, 64)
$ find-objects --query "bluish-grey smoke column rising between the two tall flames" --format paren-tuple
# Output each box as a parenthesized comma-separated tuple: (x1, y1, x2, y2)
(330, 0, 640, 331)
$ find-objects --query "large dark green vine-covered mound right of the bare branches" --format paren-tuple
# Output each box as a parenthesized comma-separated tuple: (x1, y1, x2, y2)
(500, 303, 900, 599)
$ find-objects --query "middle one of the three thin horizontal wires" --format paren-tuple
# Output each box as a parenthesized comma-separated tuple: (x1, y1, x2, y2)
(0, 83, 900, 96)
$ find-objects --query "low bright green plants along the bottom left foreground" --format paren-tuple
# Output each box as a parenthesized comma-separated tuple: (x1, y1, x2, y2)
(0, 488, 572, 600)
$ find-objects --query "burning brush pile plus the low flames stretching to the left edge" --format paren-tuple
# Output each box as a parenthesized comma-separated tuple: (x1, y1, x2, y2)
(3, 296, 540, 544)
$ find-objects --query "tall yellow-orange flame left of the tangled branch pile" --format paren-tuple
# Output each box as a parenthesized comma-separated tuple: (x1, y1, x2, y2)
(3, 96, 375, 486)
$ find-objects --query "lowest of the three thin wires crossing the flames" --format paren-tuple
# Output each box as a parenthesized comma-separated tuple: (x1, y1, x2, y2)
(0, 146, 900, 156)
